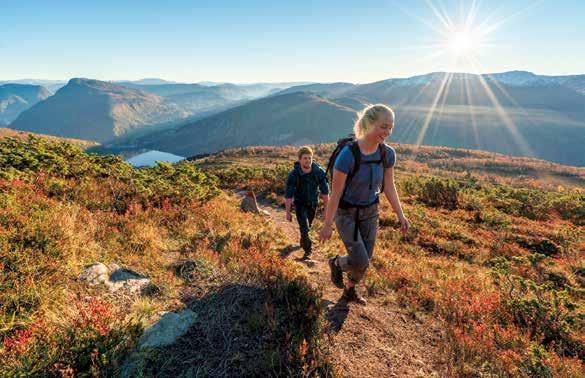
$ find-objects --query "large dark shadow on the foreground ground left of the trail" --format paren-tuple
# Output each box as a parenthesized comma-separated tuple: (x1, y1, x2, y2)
(133, 284, 334, 377)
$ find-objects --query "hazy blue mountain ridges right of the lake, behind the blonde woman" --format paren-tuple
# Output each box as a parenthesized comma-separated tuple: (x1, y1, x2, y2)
(107, 71, 585, 165)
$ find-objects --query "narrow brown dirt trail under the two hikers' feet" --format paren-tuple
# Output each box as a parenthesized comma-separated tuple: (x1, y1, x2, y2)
(261, 203, 443, 377)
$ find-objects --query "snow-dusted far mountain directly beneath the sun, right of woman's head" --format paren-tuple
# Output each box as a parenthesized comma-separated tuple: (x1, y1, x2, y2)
(266, 71, 585, 166)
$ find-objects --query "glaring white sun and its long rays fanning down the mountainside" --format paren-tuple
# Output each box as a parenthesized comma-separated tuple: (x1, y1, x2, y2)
(398, 0, 544, 158)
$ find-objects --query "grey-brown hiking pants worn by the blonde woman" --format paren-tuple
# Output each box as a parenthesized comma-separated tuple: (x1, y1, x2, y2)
(335, 203, 379, 283)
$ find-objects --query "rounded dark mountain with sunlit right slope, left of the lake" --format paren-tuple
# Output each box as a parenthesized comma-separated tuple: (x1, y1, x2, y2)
(10, 79, 186, 142)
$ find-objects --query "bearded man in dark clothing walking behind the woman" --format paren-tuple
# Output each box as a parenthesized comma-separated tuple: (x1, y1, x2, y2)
(284, 146, 329, 260)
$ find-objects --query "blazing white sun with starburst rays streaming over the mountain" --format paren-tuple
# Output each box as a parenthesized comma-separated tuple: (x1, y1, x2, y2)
(406, 0, 532, 156)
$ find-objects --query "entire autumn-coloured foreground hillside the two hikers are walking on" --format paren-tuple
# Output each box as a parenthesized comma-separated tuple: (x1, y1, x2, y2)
(0, 138, 585, 377)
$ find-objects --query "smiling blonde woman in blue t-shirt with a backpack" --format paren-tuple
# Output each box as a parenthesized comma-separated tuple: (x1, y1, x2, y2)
(319, 104, 409, 305)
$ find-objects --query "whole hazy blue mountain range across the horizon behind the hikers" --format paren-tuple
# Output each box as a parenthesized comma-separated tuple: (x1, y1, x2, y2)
(4, 71, 585, 165)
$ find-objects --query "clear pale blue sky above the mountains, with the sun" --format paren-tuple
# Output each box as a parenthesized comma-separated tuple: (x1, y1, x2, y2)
(0, 0, 585, 83)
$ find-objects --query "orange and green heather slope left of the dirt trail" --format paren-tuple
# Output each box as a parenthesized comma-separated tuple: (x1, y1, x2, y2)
(0, 137, 330, 376)
